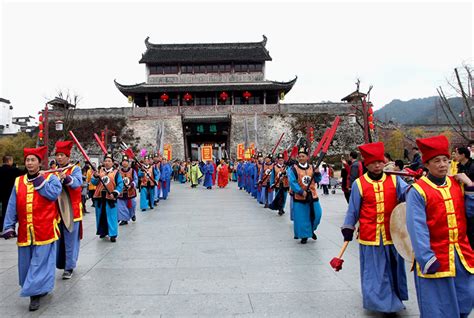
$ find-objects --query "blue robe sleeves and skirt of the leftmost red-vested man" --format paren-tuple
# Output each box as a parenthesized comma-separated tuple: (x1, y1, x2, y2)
(3, 176, 62, 297)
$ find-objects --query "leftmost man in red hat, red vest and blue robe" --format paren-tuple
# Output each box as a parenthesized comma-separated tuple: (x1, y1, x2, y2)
(3, 146, 62, 311)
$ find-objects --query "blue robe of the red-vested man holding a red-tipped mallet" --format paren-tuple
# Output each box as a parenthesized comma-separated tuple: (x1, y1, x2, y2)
(343, 177, 408, 313)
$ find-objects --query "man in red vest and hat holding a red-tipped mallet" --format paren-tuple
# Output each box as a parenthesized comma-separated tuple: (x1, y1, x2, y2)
(341, 142, 408, 314)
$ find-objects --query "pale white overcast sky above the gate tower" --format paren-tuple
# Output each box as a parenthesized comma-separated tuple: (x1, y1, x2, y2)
(0, 0, 473, 116)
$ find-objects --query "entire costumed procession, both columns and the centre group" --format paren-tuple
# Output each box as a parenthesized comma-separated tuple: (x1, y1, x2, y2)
(3, 136, 474, 318)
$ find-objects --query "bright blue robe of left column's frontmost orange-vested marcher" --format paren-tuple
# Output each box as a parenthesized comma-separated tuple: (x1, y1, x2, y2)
(91, 172, 123, 237)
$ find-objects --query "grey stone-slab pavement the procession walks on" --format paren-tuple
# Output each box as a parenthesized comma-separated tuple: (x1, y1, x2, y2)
(0, 183, 418, 318)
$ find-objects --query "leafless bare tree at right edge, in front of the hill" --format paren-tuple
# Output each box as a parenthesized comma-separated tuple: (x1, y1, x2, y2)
(436, 64, 474, 142)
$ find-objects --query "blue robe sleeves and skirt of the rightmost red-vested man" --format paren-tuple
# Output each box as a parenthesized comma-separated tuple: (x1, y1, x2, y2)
(406, 185, 474, 318)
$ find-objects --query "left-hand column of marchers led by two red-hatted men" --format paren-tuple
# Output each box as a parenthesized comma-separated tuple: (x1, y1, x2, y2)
(2, 141, 172, 311)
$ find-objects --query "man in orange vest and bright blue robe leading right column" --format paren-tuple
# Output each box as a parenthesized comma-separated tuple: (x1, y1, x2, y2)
(287, 146, 322, 244)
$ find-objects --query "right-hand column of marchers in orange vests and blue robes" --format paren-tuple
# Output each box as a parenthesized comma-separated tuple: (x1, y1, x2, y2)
(237, 149, 322, 244)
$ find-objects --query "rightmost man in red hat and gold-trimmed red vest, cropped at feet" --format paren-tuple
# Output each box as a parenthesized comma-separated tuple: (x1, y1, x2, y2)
(406, 136, 474, 318)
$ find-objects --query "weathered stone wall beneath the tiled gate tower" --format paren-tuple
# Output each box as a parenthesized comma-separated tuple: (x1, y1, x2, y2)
(63, 103, 363, 159)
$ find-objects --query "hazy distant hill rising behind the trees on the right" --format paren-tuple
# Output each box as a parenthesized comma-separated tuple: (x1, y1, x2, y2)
(374, 96, 463, 125)
